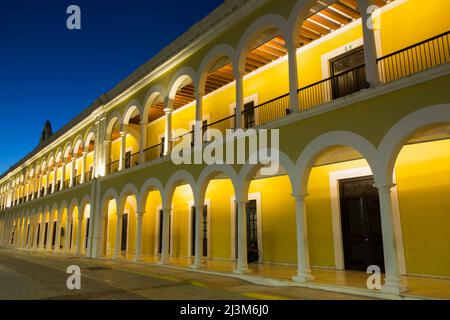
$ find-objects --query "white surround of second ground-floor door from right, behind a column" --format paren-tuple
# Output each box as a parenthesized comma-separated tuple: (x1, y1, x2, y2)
(230, 192, 264, 263)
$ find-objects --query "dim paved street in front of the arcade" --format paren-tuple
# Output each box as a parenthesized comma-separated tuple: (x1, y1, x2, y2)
(0, 249, 370, 300)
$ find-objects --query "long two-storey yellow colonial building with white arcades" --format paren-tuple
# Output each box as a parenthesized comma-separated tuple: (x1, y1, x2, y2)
(0, 0, 450, 294)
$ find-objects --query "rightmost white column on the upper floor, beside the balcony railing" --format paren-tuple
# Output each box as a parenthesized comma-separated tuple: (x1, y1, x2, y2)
(358, 0, 380, 87)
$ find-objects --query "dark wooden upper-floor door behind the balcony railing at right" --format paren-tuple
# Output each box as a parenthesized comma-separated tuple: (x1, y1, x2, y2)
(330, 48, 368, 99)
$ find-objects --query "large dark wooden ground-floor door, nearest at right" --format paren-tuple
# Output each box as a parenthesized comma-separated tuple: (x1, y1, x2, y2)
(340, 176, 384, 272)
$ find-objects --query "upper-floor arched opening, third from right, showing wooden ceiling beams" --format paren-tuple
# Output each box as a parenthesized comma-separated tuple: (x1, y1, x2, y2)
(237, 21, 289, 128)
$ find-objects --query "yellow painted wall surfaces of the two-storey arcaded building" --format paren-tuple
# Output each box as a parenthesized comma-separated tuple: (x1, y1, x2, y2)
(0, 0, 450, 298)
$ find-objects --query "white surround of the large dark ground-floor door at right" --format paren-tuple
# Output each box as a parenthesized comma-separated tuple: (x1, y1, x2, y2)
(329, 167, 406, 274)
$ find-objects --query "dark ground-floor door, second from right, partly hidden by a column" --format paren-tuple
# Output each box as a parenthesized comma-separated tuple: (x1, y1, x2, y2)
(235, 200, 259, 263)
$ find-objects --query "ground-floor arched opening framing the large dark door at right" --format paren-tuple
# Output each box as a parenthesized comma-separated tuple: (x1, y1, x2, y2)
(300, 145, 386, 279)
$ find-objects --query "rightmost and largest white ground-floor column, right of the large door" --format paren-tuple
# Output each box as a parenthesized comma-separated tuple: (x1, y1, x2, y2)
(375, 184, 407, 294)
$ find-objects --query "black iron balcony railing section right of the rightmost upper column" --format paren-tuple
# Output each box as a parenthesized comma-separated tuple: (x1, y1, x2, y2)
(377, 31, 450, 83)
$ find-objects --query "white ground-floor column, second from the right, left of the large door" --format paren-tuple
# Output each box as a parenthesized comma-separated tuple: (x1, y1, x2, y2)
(292, 195, 313, 282)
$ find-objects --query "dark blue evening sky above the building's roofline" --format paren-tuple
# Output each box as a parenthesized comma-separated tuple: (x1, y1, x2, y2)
(0, 0, 223, 174)
